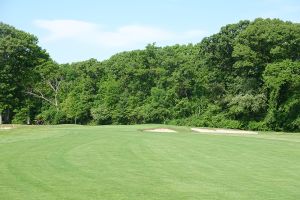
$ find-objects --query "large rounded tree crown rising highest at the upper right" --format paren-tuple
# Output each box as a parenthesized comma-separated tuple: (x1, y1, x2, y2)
(232, 18, 300, 80)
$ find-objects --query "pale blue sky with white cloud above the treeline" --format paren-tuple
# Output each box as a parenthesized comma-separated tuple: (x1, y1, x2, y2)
(0, 0, 300, 63)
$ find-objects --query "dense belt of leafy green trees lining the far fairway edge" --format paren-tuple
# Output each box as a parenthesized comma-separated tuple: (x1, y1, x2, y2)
(0, 18, 300, 131)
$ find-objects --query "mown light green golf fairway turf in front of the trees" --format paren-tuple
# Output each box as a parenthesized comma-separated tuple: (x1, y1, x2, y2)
(0, 125, 300, 200)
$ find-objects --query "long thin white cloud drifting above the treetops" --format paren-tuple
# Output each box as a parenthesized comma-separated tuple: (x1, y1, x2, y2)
(34, 20, 205, 48)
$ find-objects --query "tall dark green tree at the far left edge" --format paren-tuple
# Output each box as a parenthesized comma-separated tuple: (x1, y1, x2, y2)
(0, 22, 49, 123)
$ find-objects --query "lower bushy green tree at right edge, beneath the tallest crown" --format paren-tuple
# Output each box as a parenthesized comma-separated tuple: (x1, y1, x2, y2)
(264, 60, 300, 131)
